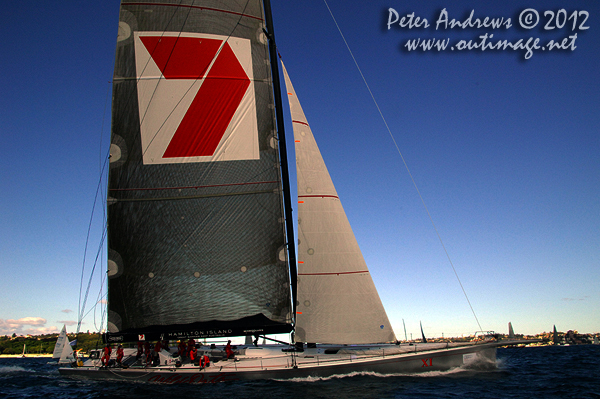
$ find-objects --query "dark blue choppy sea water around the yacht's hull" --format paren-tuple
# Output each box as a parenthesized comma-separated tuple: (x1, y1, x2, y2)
(0, 345, 600, 399)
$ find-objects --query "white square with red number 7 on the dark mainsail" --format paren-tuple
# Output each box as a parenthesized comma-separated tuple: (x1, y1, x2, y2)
(136, 32, 258, 163)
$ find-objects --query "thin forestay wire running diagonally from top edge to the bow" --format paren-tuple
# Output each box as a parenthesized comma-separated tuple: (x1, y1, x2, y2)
(323, 0, 483, 331)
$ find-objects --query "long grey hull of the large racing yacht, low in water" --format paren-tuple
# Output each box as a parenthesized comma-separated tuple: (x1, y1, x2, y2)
(59, 342, 506, 384)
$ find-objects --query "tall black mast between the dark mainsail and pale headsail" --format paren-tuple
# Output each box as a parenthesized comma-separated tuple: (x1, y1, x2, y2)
(263, 0, 298, 320)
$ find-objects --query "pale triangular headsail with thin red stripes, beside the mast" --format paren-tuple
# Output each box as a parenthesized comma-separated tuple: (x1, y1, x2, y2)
(283, 61, 396, 344)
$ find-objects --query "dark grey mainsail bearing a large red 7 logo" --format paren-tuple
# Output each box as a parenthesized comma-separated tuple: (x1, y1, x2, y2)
(108, 0, 292, 340)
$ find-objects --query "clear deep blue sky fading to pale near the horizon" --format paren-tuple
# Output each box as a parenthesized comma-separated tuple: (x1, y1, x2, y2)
(0, 0, 600, 338)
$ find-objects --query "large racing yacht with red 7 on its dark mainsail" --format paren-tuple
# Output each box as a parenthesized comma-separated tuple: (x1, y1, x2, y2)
(60, 0, 528, 383)
